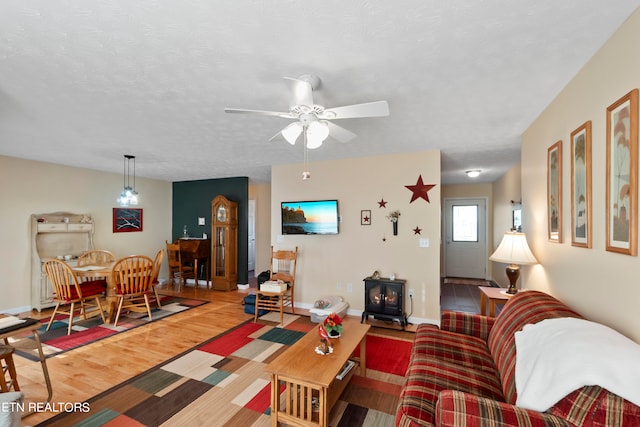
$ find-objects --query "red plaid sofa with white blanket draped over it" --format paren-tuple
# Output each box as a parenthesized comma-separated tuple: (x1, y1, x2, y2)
(396, 291, 640, 427)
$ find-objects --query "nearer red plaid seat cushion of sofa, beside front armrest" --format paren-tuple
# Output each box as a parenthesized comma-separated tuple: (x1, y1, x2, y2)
(396, 353, 504, 425)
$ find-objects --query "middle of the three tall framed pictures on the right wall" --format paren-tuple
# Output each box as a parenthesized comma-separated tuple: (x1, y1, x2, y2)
(571, 120, 592, 248)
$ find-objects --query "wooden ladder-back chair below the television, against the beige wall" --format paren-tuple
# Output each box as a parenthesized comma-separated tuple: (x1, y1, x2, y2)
(254, 246, 298, 323)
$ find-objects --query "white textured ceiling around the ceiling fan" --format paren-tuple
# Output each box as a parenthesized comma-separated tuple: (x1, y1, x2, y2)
(0, 0, 640, 183)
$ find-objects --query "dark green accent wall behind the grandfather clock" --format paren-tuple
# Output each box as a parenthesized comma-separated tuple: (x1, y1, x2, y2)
(171, 177, 249, 284)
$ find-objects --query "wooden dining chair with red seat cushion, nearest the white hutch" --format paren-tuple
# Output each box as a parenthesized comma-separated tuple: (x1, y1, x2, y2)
(43, 259, 105, 335)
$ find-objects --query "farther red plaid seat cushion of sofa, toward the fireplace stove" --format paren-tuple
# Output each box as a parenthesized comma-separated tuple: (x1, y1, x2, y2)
(413, 325, 496, 375)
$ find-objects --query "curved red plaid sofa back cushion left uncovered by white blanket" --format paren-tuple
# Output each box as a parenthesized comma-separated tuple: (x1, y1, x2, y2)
(487, 291, 581, 404)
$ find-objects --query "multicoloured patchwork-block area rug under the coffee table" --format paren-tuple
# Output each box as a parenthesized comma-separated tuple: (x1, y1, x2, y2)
(39, 316, 411, 427)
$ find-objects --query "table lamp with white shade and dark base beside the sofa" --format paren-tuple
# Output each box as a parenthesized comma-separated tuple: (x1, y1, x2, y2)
(489, 231, 538, 295)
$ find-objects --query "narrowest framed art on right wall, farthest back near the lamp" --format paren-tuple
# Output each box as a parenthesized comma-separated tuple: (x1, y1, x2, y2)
(547, 141, 562, 243)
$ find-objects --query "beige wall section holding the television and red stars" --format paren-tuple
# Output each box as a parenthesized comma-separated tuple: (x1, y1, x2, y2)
(271, 151, 441, 322)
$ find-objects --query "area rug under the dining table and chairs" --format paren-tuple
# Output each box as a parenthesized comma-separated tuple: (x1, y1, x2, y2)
(9, 296, 208, 361)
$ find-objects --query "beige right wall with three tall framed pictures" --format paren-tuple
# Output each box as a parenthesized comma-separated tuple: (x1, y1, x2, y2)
(521, 10, 640, 342)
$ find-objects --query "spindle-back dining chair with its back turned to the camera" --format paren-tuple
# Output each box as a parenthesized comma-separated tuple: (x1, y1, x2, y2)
(112, 255, 153, 326)
